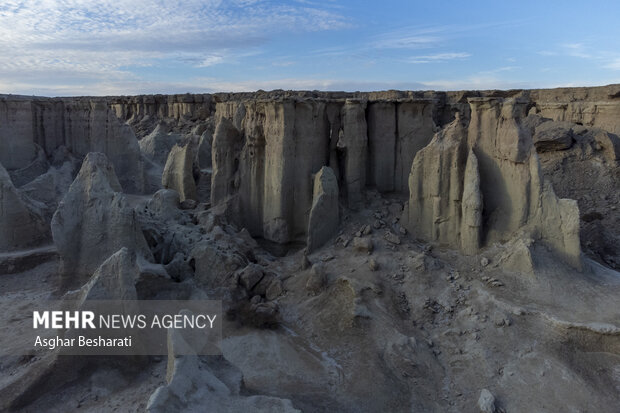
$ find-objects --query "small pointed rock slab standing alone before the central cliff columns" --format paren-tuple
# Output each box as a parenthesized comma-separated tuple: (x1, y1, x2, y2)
(307, 166, 340, 252)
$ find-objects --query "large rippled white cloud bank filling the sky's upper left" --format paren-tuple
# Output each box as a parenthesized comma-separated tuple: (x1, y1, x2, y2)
(0, 0, 349, 93)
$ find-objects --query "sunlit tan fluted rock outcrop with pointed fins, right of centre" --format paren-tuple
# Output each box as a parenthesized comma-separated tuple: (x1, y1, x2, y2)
(403, 98, 581, 268)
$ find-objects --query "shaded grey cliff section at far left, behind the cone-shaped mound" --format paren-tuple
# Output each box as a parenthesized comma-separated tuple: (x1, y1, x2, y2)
(0, 97, 145, 193)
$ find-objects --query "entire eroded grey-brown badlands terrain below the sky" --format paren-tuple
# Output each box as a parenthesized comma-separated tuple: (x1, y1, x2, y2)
(0, 85, 620, 413)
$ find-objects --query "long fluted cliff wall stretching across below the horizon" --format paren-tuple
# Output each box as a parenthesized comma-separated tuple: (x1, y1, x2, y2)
(0, 85, 620, 267)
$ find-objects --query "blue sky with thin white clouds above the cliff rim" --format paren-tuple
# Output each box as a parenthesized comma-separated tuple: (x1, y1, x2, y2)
(0, 0, 620, 96)
